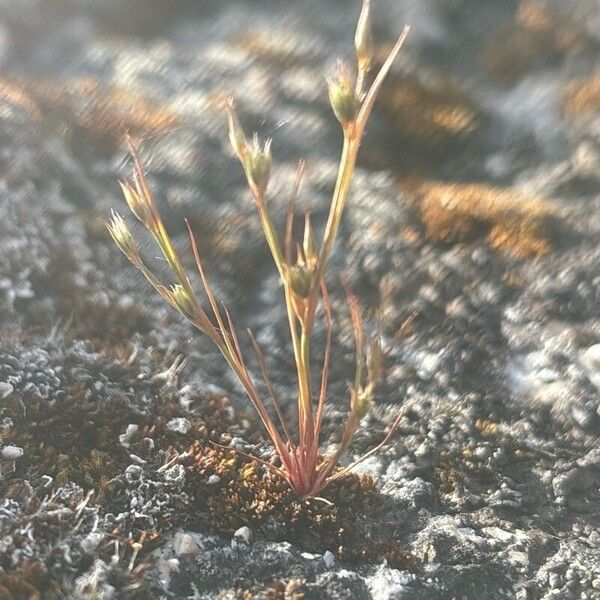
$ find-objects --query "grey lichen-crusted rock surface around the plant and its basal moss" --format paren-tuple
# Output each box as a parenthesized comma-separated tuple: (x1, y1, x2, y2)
(0, 0, 600, 600)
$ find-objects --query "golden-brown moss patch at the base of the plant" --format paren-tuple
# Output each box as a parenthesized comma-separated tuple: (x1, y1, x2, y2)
(189, 443, 414, 569)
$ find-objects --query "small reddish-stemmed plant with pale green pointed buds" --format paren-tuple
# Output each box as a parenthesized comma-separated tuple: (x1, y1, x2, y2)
(108, 0, 408, 497)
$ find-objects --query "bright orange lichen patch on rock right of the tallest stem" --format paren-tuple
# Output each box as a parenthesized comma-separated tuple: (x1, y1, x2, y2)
(414, 182, 556, 257)
